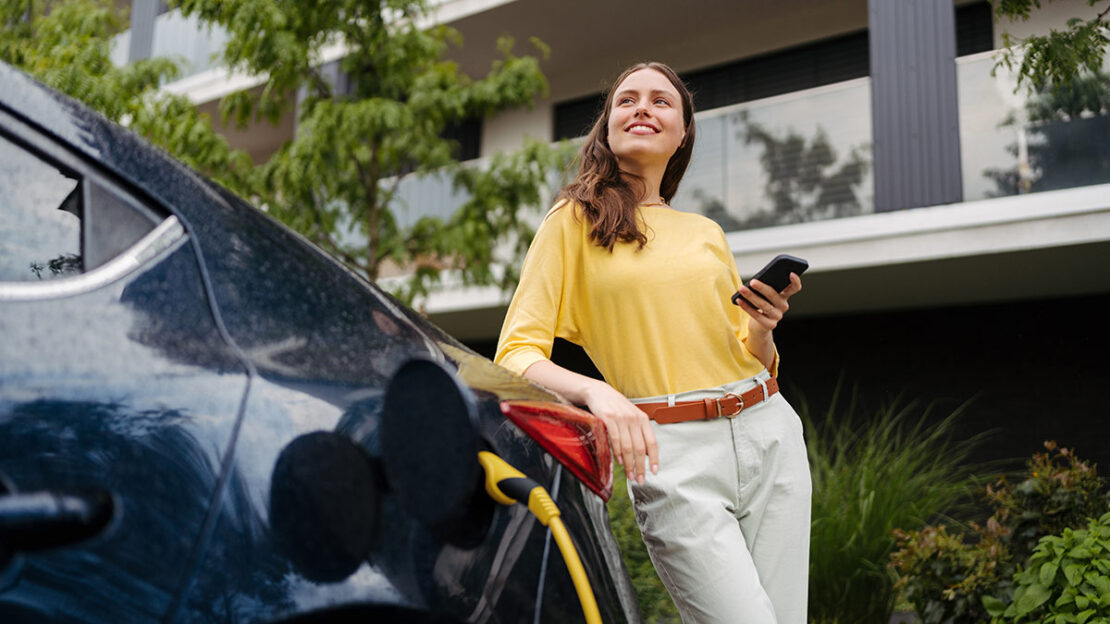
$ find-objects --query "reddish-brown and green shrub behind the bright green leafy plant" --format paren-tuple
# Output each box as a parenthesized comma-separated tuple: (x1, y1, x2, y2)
(891, 442, 1110, 624)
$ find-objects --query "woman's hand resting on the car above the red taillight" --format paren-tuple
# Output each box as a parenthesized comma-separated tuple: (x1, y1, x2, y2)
(585, 381, 659, 484)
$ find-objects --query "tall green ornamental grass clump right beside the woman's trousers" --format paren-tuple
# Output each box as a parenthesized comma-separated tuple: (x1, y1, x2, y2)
(799, 384, 979, 624)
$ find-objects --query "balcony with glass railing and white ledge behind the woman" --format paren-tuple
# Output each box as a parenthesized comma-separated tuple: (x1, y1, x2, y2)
(414, 52, 1110, 330)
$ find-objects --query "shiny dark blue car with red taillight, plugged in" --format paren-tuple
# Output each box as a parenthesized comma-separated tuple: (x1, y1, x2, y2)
(0, 66, 639, 624)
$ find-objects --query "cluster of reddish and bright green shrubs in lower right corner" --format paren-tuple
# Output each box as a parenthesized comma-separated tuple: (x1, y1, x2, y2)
(891, 442, 1110, 624)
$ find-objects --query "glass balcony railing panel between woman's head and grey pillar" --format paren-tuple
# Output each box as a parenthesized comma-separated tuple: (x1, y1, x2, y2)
(672, 78, 875, 232)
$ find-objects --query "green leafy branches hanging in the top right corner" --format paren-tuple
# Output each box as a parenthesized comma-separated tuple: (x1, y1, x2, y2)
(993, 0, 1110, 90)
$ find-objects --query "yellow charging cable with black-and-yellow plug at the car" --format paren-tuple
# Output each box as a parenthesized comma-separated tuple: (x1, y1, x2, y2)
(478, 451, 602, 624)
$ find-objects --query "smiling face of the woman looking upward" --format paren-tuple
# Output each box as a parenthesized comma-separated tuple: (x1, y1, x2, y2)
(608, 69, 686, 172)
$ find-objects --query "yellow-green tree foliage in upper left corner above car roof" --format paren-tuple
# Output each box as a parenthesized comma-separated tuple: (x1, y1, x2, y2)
(0, 0, 251, 194)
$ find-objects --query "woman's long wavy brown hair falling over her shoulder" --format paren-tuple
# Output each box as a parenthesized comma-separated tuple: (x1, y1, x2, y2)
(559, 62, 694, 252)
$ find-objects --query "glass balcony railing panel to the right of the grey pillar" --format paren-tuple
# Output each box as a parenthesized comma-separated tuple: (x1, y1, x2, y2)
(956, 52, 1110, 201)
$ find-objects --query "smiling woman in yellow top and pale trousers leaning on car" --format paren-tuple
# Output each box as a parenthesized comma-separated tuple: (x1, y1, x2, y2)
(495, 63, 810, 624)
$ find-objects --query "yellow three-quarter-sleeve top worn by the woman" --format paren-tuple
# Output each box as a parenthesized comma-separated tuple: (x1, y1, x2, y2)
(494, 202, 778, 399)
